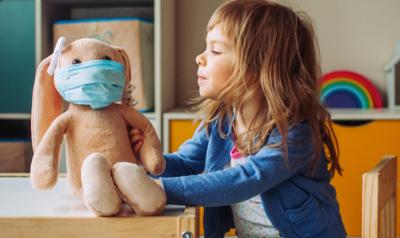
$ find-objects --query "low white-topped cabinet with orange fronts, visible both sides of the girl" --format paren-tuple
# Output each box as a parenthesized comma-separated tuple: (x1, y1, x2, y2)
(164, 110, 400, 236)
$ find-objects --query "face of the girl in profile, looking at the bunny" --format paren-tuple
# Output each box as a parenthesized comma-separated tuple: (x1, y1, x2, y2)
(196, 24, 234, 100)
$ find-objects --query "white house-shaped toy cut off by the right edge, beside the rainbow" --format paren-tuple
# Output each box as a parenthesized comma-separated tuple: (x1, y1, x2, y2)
(385, 42, 400, 108)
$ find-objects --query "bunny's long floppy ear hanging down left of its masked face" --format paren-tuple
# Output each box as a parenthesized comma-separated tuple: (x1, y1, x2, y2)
(31, 56, 63, 151)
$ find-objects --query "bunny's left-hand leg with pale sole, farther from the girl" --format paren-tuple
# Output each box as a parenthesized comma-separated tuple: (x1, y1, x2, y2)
(81, 153, 122, 216)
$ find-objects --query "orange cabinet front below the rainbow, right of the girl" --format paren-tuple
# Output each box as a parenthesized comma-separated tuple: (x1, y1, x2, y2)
(332, 118, 400, 236)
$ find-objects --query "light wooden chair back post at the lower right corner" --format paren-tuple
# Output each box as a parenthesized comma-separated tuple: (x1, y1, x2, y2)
(362, 155, 397, 238)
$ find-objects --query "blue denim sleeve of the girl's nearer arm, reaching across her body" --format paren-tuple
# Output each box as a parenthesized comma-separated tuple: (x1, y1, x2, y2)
(162, 124, 313, 206)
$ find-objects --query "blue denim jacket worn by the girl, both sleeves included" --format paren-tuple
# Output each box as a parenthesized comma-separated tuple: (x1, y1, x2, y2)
(161, 122, 346, 238)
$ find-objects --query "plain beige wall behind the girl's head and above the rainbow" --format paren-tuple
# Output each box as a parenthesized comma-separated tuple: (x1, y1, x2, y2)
(176, 0, 400, 105)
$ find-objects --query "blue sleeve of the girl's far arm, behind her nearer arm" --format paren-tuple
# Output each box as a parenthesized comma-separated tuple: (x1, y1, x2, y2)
(160, 122, 208, 177)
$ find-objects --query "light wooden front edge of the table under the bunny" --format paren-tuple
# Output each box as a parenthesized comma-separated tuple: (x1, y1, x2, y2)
(0, 216, 179, 238)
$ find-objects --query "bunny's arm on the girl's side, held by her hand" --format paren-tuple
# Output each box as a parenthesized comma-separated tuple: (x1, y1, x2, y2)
(118, 104, 165, 175)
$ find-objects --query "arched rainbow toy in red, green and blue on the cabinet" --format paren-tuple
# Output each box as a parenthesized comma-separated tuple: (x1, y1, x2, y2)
(321, 71, 382, 109)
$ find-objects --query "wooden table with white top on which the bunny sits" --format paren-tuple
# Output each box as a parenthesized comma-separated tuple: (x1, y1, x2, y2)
(0, 175, 198, 238)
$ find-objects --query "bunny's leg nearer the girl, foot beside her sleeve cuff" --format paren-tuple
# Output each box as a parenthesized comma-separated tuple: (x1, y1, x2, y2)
(112, 162, 167, 215)
